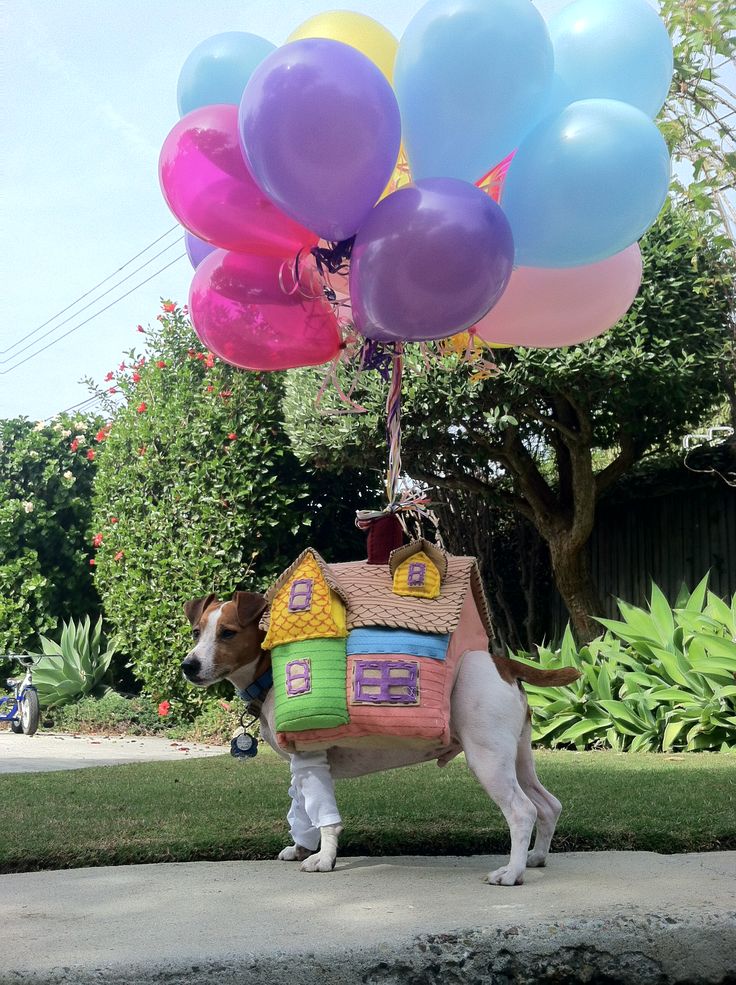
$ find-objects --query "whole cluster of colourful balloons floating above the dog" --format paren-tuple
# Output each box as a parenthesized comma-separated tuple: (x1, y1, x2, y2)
(160, 0, 672, 370)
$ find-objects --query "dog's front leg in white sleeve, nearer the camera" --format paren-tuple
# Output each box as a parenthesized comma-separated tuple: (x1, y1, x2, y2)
(291, 752, 342, 872)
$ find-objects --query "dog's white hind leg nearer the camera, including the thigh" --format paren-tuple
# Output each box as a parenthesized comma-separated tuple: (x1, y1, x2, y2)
(452, 650, 537, 886)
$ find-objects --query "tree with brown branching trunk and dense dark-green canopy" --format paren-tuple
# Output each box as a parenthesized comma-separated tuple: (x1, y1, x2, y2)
(284, 209, 733, 639)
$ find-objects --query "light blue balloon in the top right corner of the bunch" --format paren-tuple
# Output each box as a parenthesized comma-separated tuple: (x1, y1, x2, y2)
(549, 0, 672, 117)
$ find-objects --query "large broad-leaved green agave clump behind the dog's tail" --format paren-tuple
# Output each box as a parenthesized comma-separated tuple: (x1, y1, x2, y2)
(515, 575, 736, 752)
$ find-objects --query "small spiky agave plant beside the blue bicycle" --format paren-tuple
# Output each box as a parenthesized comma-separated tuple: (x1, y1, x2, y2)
(28, 616, 115, 708)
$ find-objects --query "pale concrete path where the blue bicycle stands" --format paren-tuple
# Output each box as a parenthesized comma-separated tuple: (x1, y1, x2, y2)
(0, 729, 229, 772)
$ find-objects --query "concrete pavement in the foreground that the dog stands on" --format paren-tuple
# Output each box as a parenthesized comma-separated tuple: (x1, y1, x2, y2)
(0, 852, 736, 985)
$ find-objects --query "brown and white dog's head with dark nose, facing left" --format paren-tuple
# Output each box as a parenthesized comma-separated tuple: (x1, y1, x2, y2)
(181, 592, 267, 687)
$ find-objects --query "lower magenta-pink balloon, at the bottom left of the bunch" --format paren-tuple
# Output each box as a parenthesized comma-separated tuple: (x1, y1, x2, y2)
(189, 250, 340, 370)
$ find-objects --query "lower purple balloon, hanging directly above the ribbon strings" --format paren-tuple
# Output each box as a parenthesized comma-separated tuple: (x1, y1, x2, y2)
(350, 178, 514, 342)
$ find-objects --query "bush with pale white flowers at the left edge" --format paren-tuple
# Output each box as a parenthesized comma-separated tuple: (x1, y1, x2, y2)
(0, 415, 103, 671)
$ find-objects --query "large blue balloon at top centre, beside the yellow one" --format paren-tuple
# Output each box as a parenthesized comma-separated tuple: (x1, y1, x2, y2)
(394, 0, 552, 182)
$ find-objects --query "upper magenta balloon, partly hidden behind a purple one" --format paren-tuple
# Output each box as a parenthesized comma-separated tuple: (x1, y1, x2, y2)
(159, 106, 317, 257)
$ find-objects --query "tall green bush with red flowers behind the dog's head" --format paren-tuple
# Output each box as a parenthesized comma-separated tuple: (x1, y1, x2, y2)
(92, 302, 363, 715)
